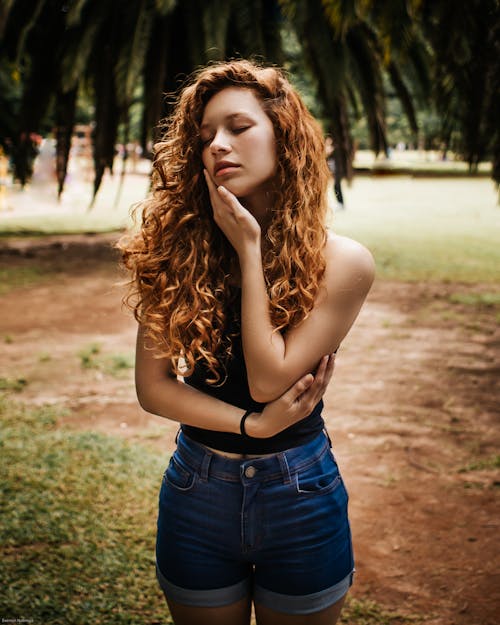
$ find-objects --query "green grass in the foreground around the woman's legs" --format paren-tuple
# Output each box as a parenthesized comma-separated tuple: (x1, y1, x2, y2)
(0, 395, 426, 625)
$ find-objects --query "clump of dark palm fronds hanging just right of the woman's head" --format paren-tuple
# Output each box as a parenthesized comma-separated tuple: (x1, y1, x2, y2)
(281, 0, 427, 178)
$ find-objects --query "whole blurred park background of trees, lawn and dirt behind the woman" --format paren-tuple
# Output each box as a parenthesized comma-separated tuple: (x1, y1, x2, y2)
(0, 0, 500, 625)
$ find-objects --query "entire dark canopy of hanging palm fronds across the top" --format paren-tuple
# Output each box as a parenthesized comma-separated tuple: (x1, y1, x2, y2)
(0, 0, 500, 197)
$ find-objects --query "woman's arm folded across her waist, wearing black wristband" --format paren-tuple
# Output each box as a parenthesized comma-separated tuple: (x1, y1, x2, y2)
(135, 326, 334, 438)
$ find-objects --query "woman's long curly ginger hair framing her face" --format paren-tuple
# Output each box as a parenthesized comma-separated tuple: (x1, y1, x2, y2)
(118, 60, 329, 384)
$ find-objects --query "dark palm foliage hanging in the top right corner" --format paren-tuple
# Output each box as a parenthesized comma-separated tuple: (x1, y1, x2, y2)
(421, 0, 500, 183)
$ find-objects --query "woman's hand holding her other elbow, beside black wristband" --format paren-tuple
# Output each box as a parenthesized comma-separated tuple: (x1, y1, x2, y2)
(245, 354, 335, 438)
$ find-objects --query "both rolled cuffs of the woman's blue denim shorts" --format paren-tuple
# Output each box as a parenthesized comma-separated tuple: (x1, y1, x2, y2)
(156, 565, 354, 614)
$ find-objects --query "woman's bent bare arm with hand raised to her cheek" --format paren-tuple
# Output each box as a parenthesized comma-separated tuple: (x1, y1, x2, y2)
(207, 173, 374, 402)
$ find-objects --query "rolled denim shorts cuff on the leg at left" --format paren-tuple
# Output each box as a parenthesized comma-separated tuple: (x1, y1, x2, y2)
(156, 565, 251, 608)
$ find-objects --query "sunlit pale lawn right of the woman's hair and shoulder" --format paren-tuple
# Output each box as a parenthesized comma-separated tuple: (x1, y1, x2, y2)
(333, 176, 500, 283)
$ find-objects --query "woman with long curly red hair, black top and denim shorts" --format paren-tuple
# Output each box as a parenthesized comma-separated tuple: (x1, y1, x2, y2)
(121, 61, 374, 625)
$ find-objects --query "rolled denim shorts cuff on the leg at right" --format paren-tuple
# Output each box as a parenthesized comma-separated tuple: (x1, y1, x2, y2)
(254, 571, 354, 614)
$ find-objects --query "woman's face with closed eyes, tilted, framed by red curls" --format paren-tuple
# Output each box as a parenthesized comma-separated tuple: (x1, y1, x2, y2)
(200, 87, 277, 212)
